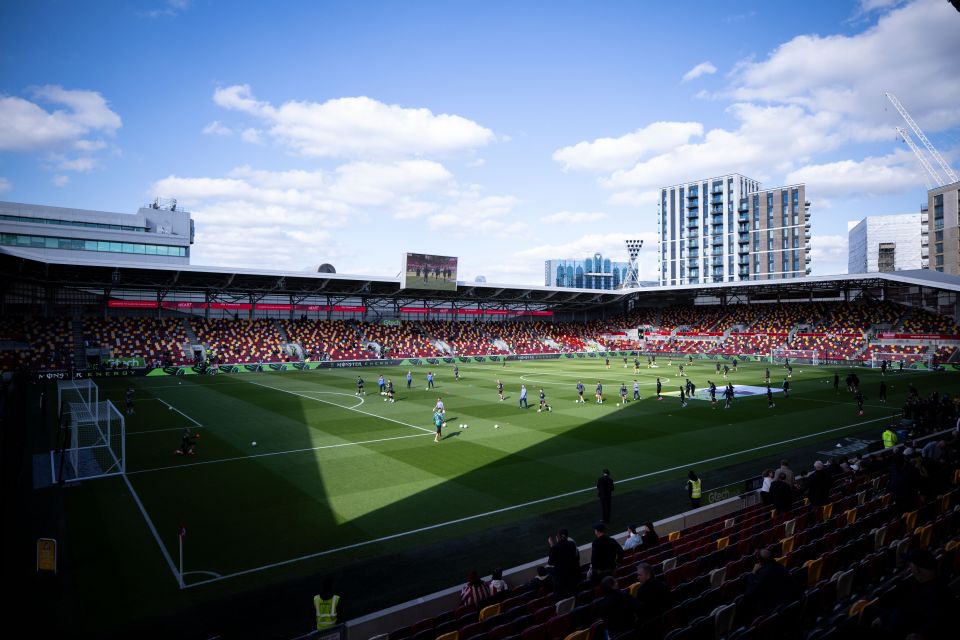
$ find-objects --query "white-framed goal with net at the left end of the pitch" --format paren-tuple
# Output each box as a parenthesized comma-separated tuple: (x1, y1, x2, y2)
(50, 380, 126, 482)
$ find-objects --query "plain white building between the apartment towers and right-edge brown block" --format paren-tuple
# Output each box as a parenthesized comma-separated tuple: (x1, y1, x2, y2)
(847, 212, 930, 273)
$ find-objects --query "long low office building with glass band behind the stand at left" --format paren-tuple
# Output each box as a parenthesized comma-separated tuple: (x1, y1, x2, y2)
(0, 201, 194, 266)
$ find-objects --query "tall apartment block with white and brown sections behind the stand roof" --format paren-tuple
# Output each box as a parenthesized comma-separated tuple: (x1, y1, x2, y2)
(657, 173, 810, 286)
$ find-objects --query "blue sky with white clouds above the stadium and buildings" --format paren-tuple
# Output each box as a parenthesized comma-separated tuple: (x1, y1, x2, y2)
(0, 0, 960, 284)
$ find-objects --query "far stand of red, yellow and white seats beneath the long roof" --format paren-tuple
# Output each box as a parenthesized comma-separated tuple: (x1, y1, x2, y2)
(0, 302, 960, 369)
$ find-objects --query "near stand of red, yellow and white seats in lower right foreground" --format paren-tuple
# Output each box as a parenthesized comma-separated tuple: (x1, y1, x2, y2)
(370, 442, 960, 640)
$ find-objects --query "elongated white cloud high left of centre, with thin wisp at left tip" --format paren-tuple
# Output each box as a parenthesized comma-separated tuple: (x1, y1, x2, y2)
(213, 85, 494, 158)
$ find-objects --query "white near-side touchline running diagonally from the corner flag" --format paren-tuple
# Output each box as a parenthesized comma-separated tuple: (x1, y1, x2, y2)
(178, 412, 888, 588)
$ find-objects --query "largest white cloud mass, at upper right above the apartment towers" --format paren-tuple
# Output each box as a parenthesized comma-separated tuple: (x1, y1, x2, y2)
(553, 0, 960, 207)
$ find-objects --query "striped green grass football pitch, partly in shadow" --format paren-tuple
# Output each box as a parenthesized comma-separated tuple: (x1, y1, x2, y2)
(48, 357, 960, 632)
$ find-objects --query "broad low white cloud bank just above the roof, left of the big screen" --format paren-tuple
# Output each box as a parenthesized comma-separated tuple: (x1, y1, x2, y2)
(149, 160, 526, 269)
